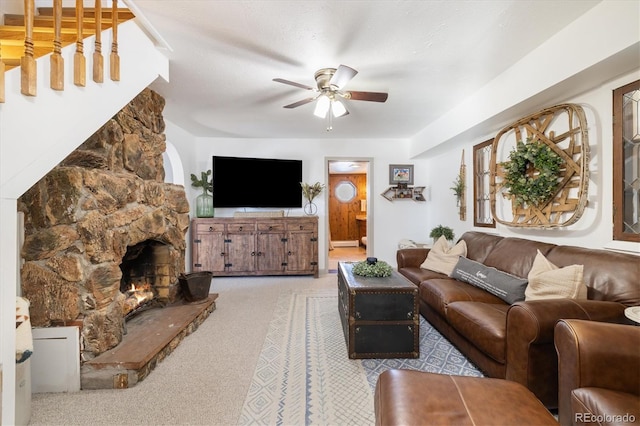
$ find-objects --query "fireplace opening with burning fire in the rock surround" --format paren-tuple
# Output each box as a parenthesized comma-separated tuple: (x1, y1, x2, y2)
(120, 240, 174, 320)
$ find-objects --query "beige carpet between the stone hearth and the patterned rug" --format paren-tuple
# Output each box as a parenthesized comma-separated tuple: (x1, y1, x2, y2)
(30, 274, 337, 425)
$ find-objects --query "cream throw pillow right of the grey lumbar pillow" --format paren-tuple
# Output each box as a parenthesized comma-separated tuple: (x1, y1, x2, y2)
(525, 250, 587, 300)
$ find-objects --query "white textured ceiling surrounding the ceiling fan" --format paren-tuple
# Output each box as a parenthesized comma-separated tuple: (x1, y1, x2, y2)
(134, 0, 598, 139)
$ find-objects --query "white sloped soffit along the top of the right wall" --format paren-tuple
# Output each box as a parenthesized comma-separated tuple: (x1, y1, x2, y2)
(411, 0, 640, 156)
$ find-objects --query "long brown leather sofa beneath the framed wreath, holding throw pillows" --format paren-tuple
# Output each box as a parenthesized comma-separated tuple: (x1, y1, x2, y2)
(397, 232, 640, 408)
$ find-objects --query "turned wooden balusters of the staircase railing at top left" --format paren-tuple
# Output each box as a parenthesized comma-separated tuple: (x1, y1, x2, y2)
(0, 0, 131, 103)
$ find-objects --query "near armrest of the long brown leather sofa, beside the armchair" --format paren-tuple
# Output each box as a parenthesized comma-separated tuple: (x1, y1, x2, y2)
(505, 299, 625, 408)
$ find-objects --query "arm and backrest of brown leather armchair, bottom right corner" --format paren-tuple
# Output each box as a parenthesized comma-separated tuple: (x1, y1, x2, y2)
(554, 319, 640, 425)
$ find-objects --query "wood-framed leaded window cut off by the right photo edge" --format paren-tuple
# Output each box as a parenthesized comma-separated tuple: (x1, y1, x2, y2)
(613, 80, 640, 242)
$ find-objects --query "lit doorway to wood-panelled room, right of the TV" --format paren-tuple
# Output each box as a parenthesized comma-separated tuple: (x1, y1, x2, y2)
(327, 158, 371, 272)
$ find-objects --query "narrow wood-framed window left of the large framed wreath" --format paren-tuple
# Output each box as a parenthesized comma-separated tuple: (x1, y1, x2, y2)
(473, 139, 496, 228)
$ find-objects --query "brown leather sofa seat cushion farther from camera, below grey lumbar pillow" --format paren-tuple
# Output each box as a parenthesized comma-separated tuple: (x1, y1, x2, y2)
(418, 278, 505, 318)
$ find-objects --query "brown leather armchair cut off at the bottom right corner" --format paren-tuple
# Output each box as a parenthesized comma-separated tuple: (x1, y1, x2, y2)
(554, 319, 640, 426)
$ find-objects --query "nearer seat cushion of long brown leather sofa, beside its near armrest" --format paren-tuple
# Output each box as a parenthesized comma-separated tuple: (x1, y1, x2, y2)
(447, 302, 509, 364)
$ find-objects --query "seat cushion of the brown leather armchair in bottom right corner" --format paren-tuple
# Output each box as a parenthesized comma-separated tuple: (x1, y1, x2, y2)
(571, 388, 640, 425)
